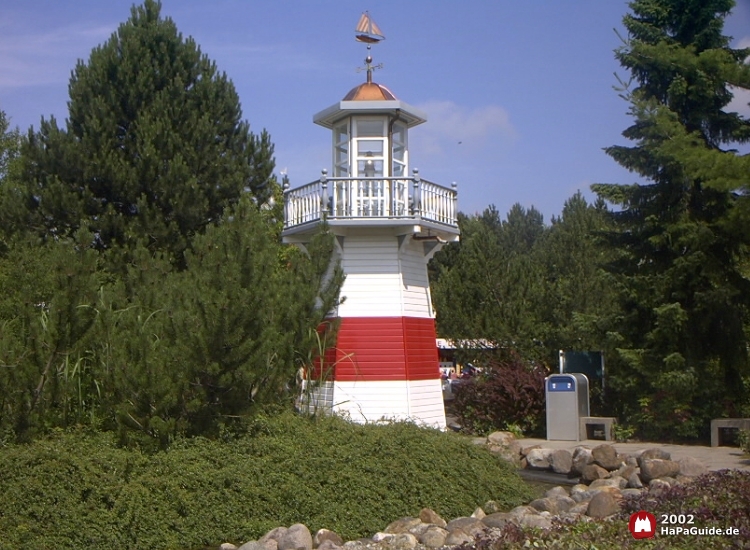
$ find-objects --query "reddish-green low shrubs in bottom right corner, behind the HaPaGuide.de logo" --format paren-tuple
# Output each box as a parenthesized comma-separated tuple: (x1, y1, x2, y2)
(476, 470, 750, 550)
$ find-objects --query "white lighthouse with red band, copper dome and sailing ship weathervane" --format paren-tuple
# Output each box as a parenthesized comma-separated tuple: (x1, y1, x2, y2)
(282, 14, 459, 428)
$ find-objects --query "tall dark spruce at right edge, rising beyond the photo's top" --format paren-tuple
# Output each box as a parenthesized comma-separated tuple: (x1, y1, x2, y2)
(594, 0, 750, 437)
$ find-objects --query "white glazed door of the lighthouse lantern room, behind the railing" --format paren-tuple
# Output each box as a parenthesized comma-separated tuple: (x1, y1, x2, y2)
(353, 117, 390, 216)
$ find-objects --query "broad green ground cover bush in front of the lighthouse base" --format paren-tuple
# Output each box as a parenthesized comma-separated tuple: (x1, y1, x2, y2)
(0, 414, 533, 550)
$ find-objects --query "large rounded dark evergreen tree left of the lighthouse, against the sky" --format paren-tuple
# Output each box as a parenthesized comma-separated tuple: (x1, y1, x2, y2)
(19, 0, 273, 263)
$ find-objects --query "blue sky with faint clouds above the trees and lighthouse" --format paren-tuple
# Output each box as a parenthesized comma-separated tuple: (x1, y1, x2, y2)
(0, 0, 750, 221)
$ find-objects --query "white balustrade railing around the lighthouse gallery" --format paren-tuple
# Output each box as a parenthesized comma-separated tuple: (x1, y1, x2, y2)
(284, 170, 458, 229)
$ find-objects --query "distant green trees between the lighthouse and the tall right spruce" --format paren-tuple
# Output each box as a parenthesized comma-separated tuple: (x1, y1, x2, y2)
(430, 193, 614, 370)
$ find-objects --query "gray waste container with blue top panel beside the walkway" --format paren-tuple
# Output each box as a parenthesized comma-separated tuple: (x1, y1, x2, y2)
(544, 372, 589, 441)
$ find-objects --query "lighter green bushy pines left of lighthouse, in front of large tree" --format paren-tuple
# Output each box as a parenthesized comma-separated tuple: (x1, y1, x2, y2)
(0, 197, 342, 447)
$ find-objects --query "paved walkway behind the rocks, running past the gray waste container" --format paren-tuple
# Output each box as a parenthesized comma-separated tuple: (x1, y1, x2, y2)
(518, 439, 750, 470)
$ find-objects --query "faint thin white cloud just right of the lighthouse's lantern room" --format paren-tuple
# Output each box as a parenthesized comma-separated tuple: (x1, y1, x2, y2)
(414, 101, 517, 156)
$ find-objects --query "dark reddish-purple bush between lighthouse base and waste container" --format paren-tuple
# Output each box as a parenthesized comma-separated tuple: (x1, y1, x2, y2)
(454, 357, 548, 436)
